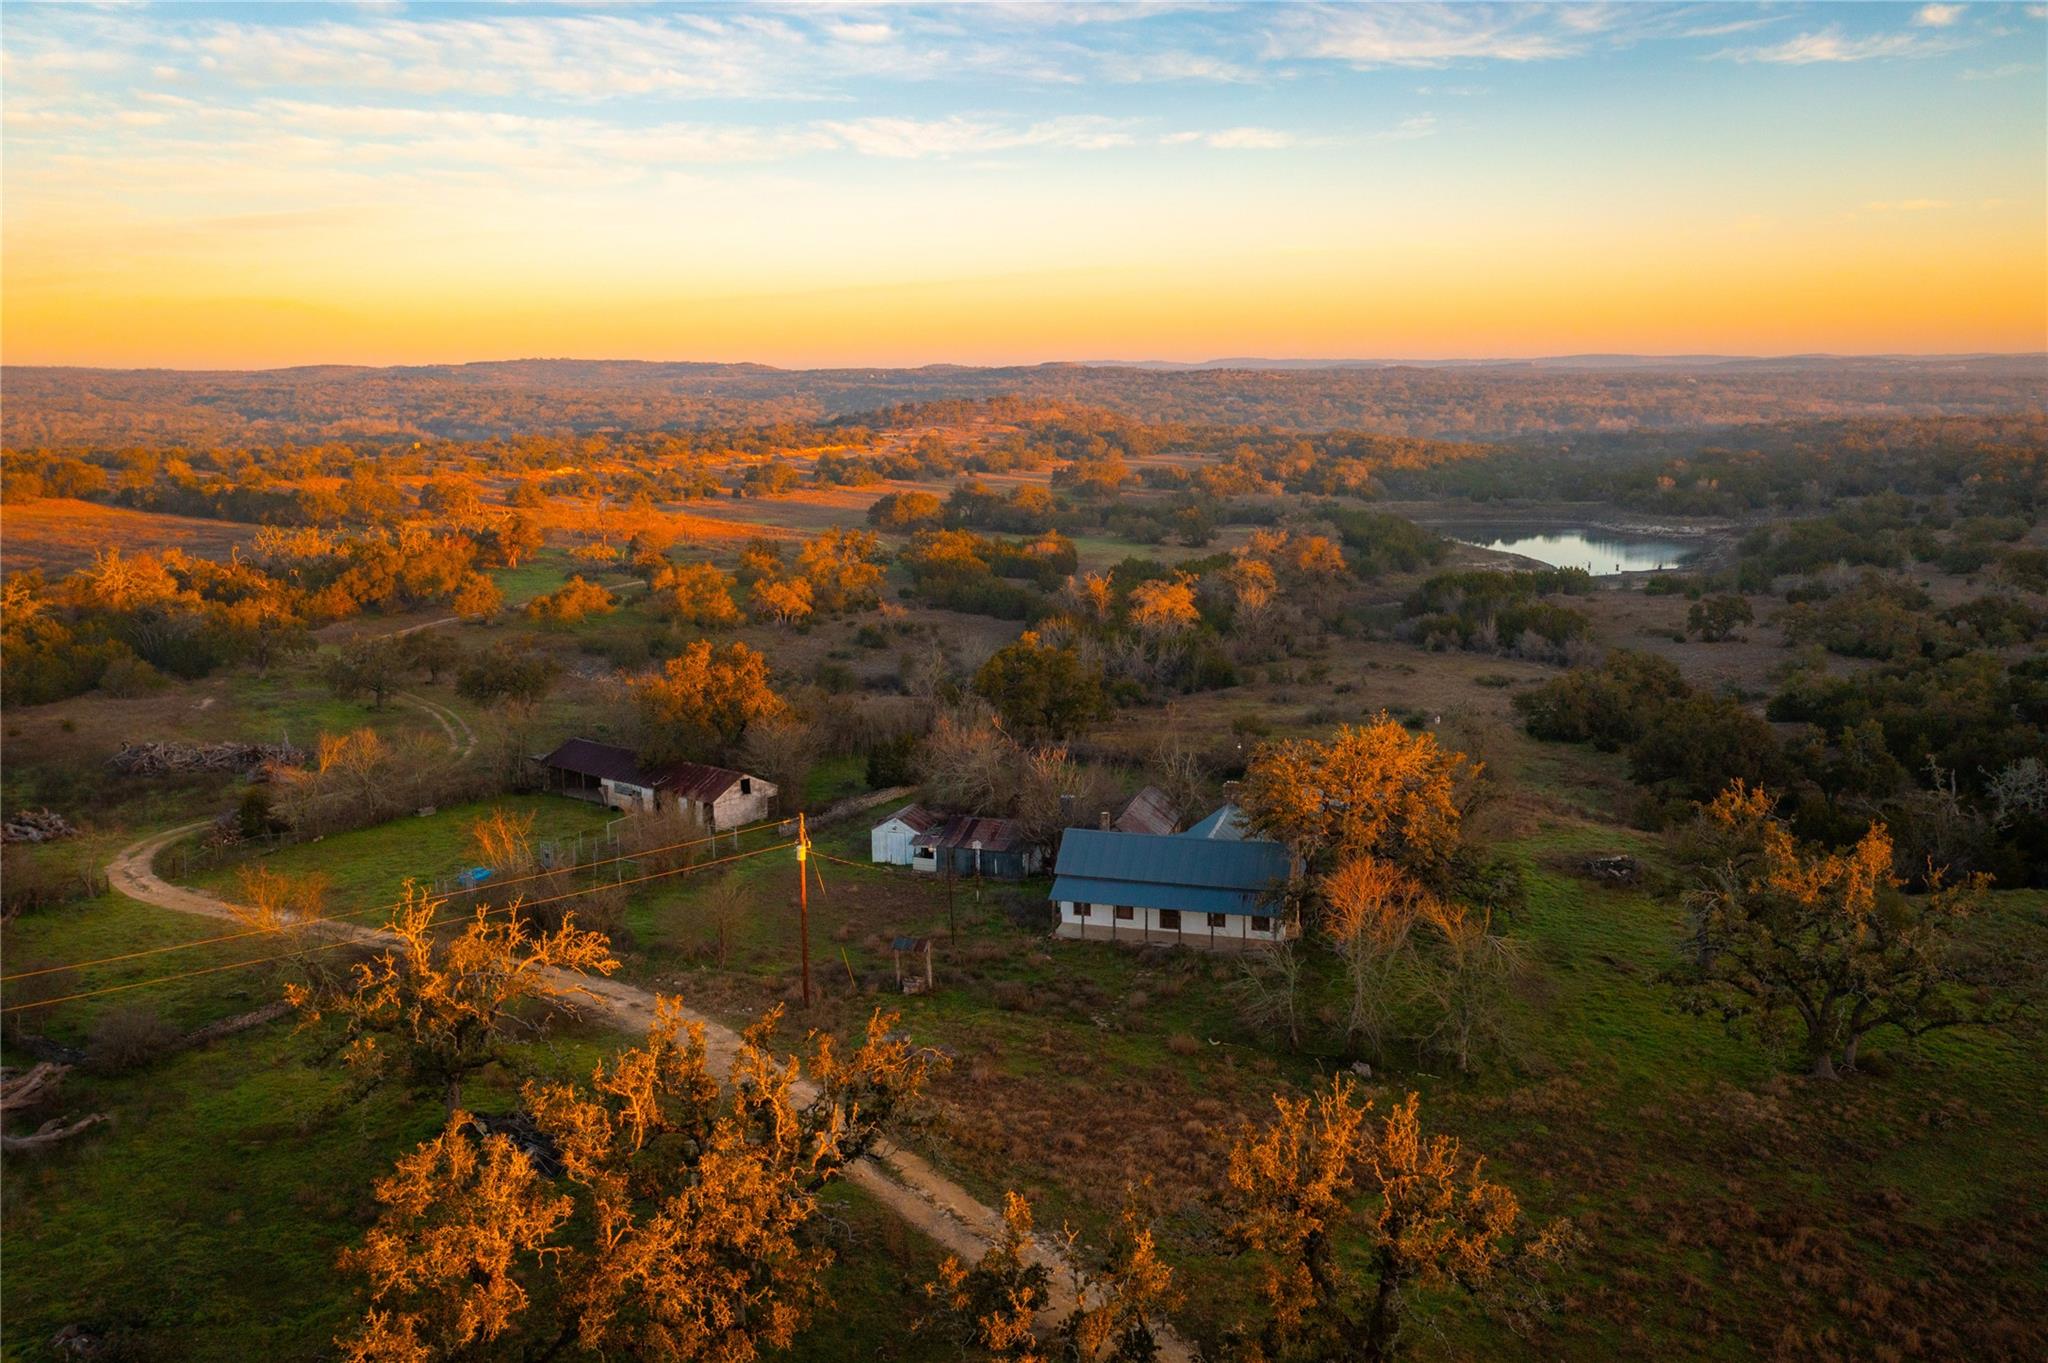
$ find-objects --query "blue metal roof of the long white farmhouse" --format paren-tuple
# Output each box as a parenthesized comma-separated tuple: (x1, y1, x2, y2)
(1051, 829, 1288, 913)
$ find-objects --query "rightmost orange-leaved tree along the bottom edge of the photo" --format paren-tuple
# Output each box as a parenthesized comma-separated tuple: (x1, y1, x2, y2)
(1225, 1076, 1571, 1363)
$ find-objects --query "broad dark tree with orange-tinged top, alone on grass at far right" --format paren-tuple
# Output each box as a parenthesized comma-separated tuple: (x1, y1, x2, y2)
(1667, 782, 1998, 1079)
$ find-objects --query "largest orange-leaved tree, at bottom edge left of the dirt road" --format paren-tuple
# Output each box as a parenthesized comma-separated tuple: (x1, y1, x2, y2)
(342, 999, 930, 1363)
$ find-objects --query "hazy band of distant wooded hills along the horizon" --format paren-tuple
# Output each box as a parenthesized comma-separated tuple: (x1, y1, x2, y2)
(0, 354, 2048, 446)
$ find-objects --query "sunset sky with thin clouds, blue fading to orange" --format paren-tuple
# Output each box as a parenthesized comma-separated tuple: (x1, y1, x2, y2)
(0, 0, 2048, 368)
